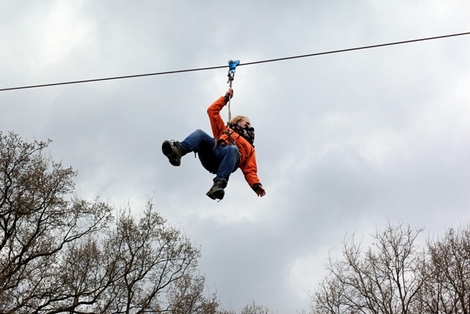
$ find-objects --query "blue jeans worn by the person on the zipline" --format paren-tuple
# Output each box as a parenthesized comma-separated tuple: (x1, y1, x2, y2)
(180, 130, 240, 181)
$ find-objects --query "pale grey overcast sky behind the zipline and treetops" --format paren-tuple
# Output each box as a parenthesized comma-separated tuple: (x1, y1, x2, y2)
(0, 0, 470, 314)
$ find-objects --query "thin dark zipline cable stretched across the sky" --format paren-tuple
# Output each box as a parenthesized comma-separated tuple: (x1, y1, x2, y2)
(0, 32, 470, 92)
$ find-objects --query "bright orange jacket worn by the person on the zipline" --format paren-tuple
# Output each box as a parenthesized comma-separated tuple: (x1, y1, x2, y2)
(207, 96, 261, 189)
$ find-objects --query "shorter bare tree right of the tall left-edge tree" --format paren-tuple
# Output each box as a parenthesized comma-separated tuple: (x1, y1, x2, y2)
(33, 202, 219, 314)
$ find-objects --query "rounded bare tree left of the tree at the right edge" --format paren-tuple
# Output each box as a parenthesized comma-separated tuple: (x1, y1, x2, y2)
(311, 224, 424, 314)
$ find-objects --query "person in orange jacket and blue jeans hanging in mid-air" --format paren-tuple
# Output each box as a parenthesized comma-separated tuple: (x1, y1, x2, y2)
(162, 87, 266, 200)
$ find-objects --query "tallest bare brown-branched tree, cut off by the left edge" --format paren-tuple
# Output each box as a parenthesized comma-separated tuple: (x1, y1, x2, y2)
(0, 132, 111, 313)
